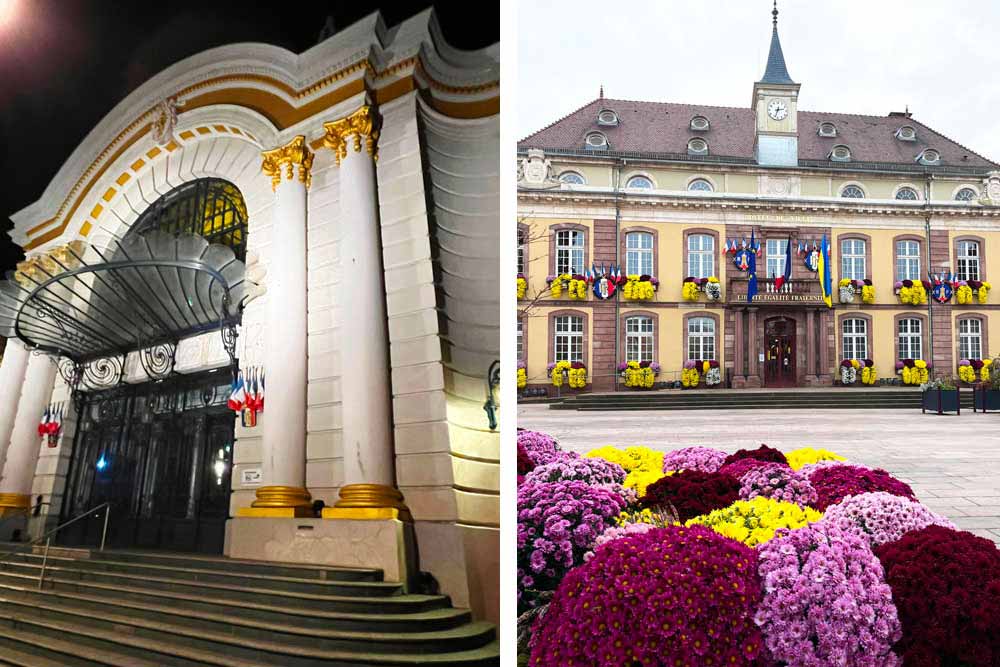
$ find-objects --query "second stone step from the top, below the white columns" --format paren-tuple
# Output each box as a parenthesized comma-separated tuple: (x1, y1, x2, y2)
(12, 551, 403, 597)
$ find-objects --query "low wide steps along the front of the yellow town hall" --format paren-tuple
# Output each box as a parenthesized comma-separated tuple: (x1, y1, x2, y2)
(549, 387, 972, 412)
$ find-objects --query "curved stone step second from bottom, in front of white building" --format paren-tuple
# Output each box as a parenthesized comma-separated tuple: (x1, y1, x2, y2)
(0, 589, 494, 664)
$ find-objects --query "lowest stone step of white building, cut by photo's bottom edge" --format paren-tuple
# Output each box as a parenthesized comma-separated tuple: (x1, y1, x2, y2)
(0, 605, 500, 667)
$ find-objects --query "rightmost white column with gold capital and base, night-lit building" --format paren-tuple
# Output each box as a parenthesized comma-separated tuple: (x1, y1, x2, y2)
(323, 104, 410, 519)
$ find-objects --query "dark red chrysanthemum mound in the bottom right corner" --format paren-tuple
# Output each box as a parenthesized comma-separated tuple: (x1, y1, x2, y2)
(875, 526, 1000, 667)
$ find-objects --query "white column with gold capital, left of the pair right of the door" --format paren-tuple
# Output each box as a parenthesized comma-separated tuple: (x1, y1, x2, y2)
(238, 135, 313, 517)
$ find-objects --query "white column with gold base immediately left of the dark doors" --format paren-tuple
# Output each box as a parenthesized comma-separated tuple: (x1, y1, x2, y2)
(0, 354, 56, 516)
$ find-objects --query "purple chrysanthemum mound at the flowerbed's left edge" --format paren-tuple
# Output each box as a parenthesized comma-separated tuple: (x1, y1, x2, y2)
(517, 481, 625, 613)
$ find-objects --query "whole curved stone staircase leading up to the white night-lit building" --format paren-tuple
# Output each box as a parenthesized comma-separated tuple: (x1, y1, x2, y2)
(0, 548, 500, 667)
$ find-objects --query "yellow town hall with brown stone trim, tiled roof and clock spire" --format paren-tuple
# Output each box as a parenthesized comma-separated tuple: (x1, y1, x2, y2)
(518, 14, 1000, 393)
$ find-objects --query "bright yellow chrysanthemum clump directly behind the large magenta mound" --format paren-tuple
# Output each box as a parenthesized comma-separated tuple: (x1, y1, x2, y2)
(684, 496, 823, 547)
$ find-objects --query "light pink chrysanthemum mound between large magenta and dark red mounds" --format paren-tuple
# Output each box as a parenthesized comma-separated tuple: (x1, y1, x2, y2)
(755, 524, 902, 667)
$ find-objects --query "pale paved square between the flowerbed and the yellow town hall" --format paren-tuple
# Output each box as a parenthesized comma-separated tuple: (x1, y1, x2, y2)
(518, 405, 1000, 543)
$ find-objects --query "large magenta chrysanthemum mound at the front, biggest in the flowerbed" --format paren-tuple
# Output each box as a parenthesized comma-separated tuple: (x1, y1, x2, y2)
(528, 526, 761, 667)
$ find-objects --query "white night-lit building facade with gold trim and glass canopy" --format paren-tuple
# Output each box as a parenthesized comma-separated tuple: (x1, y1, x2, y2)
(0, 10, 500, 640)
